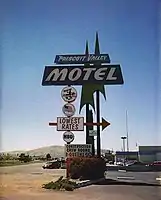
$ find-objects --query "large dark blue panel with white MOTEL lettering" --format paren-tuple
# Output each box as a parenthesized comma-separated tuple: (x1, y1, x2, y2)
(42, 64, 124, 86)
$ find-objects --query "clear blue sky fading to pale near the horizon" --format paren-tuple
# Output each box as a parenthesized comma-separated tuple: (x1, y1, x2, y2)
(1, 0, 161, 150)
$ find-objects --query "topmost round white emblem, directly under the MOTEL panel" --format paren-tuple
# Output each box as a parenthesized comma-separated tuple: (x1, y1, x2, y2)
(61, 86, 77, 103)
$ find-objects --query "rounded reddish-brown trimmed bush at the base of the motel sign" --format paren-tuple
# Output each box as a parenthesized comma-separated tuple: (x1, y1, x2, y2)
(69, 157, 106, 180)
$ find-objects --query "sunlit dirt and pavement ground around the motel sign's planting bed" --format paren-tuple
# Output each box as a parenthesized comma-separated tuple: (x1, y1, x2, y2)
(0, 163, 161, 200)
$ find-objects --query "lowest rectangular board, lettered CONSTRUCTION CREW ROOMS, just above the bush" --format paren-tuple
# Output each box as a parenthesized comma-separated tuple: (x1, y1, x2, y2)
(65, 144, 92, 157)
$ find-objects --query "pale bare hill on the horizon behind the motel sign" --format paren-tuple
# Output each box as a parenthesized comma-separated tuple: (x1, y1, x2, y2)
(1, 146, 109, 157)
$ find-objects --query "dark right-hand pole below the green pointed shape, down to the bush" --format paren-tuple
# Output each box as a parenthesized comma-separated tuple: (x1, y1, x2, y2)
(96, 91, 101, 157)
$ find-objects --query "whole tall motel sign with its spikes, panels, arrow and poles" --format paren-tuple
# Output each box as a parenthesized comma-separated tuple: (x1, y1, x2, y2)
(42, 32, 124, 163)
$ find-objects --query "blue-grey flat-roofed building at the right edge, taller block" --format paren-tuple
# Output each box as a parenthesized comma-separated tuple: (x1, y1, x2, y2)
(138, 146, 161, 163)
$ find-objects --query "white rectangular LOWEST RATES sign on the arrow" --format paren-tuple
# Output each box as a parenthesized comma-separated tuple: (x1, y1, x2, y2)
(57, 117, 84, 131)
